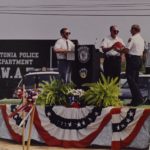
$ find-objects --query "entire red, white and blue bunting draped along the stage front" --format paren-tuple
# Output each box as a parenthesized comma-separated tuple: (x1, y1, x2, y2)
(0, 105, 150, 150)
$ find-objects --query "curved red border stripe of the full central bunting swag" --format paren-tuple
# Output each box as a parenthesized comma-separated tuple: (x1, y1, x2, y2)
(34, 106, 111, 148)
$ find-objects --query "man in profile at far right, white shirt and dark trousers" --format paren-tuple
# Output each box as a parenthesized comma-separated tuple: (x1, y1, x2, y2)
(116, 24, 147, 106)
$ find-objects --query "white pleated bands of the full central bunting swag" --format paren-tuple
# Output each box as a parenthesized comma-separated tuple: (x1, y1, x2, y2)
(37, 106, 112, 141)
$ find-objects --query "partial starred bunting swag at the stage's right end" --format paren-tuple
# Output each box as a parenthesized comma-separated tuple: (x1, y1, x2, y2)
(112, 108, 150, 150)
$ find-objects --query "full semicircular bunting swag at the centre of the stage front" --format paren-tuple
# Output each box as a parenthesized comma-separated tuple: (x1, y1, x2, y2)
(34, 106, 111, 147)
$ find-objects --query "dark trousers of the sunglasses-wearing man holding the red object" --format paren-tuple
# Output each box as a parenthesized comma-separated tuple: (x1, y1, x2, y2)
(103, 56, 121, 82)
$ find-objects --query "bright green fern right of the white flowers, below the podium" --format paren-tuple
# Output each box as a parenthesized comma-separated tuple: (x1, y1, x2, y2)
(84, 74, 122, 107)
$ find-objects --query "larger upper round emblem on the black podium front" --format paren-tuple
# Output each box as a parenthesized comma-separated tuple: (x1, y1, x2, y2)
(78, 46, 90, 63)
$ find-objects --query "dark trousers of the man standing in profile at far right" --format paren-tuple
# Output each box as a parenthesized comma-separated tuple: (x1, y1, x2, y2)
(126, 54, 143, 106)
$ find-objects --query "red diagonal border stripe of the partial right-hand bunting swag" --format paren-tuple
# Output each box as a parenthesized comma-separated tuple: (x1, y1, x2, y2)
(121, 109, 150, 147)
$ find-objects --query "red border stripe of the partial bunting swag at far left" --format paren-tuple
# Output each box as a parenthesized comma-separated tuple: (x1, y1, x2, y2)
(1, 105, 22, 143)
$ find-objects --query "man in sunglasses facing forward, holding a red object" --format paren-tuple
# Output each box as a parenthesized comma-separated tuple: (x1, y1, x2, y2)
(101, 25, 124, 81)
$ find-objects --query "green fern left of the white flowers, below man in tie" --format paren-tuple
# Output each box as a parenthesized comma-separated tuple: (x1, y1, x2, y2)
(37, 80, 75, 105)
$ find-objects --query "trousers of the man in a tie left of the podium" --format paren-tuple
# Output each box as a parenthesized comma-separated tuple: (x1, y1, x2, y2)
(58, 59, 73, 83)
